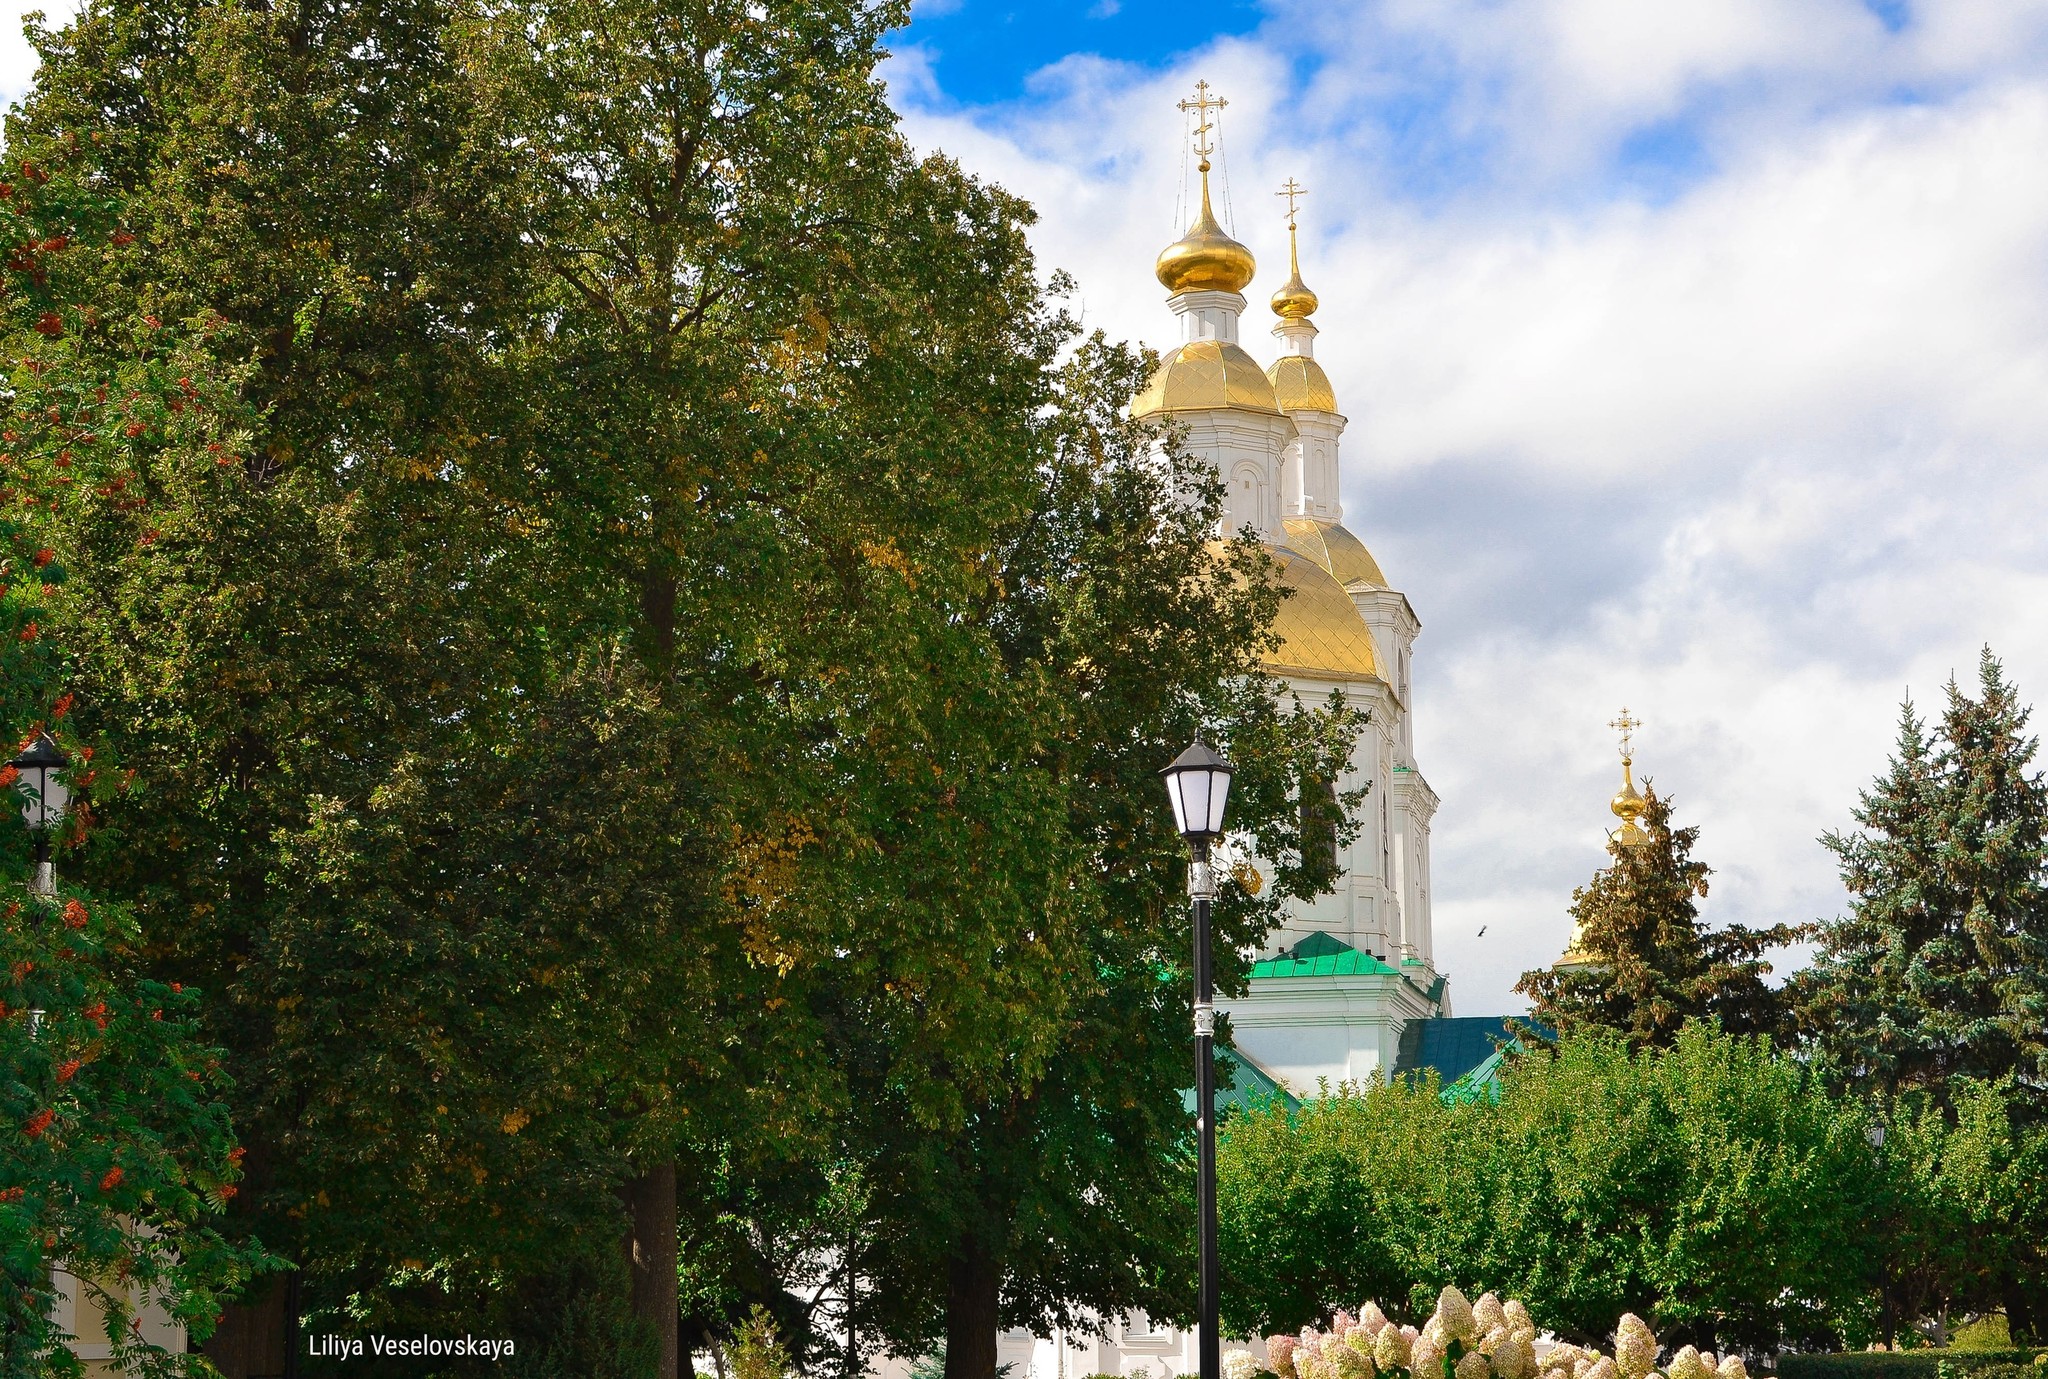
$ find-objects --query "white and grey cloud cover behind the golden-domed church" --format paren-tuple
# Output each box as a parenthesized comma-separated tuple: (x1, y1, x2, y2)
(907, 0, 2048, 1012)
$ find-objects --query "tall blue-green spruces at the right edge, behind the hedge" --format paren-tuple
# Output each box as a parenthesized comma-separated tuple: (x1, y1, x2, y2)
(1796, 647, 2048, 1115)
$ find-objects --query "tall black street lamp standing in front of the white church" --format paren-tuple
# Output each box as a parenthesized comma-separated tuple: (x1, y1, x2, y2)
(1159, 738, 1233, 1379)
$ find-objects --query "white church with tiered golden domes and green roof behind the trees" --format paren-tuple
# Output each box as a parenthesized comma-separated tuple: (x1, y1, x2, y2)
(997, 82, 1509, 1379)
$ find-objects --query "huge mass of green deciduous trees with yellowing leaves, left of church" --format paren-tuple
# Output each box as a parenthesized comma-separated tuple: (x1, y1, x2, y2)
(8, 0, 1348, 1379)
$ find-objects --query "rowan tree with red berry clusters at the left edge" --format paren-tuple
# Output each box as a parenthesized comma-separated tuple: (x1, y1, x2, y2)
(0, 155, 274, 1375)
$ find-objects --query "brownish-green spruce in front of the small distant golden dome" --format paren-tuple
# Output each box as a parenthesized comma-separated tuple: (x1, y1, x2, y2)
(1516, 787, 1804, 1047)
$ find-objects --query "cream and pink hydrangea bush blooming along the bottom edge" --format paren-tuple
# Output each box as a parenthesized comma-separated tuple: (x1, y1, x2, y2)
(1253, 1289, 1749, 1379)
